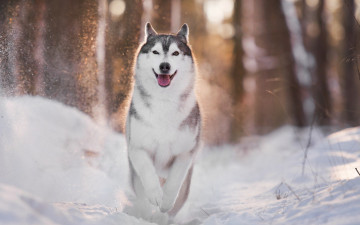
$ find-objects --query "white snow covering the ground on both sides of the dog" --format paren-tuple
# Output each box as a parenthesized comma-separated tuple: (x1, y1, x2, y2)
(0, 97, 360, 225)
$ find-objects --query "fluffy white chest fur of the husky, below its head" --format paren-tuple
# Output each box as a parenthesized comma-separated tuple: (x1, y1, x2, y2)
(130, 94, 196, 177)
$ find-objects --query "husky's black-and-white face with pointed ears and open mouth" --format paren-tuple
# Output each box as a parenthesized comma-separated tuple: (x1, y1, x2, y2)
(136, 23, 194, 92)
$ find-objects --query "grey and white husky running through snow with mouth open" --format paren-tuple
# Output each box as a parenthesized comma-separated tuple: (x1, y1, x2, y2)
(126, 23, 201, 221)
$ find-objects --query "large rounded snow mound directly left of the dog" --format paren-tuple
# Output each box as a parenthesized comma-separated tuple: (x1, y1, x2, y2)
(0, 97, 128, 207)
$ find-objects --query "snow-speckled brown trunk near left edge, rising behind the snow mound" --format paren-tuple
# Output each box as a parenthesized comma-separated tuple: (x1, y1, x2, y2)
(9, 0, 45, 95)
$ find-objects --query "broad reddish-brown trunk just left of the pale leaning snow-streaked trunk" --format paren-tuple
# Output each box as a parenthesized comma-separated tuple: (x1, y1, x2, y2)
(255, 0, 305, 133)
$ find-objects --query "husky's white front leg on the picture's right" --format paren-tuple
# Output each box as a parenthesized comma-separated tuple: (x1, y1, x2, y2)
(160, 152, 192, 212)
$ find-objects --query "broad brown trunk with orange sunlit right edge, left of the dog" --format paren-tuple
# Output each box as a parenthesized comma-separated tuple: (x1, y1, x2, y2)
(44, 0, 98, 116)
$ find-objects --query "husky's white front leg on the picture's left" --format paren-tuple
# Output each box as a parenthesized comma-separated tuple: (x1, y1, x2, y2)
(129, 148, 163, 207)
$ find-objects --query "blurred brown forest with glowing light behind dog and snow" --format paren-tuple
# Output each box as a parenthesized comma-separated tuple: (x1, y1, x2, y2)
(0, 0, 360, 145)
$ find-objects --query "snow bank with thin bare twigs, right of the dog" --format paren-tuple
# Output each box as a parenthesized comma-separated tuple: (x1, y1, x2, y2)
(182, 127, 360, 225)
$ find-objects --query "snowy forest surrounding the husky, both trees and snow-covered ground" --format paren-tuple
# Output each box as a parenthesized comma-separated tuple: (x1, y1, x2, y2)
(0, 0, 360, 225)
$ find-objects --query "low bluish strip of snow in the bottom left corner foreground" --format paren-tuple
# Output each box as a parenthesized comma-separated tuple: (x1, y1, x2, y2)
(0, 184, 155, 225)
